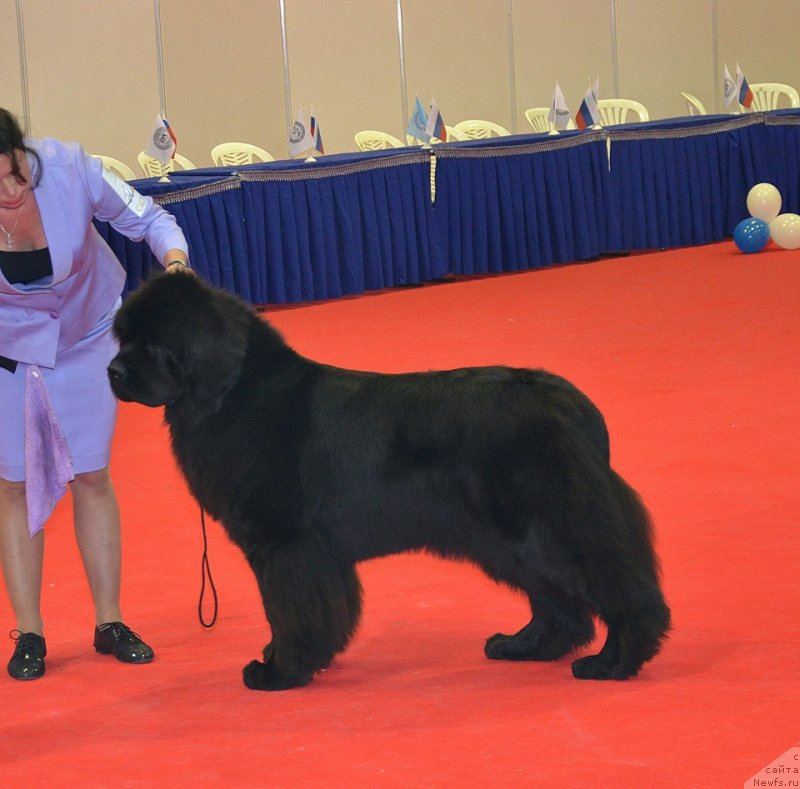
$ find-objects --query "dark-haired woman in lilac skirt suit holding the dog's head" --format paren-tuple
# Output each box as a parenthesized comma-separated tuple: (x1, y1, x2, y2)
(0, 108, 188, 679)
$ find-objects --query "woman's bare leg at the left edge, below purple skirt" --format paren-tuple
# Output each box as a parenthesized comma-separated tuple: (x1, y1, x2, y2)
(0, 479, 44, 636)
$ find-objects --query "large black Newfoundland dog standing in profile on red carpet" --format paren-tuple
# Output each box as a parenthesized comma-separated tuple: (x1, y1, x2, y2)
(108, 273, 670, 690)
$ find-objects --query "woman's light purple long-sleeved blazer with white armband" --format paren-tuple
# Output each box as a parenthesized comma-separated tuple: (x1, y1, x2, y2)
(0, 139, 188, 368)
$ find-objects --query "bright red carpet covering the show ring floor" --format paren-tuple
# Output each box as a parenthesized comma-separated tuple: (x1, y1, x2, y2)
(0, 243, 800, 788)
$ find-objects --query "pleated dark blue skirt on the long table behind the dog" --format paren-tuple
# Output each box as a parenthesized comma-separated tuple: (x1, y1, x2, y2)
(97, 110, 800, 304)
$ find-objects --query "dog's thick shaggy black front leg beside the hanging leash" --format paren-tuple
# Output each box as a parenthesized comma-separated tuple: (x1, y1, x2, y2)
(243, 542, 361, 690)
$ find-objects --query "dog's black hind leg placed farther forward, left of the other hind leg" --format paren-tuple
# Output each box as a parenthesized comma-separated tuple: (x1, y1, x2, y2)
(484, 588, 594, 660)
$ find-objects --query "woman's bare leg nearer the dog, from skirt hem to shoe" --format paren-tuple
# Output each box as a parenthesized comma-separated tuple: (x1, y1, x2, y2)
(71, 467, 122, 625)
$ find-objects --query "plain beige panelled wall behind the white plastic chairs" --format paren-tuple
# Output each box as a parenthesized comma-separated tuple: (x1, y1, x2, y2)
(0, 0, 800, 169)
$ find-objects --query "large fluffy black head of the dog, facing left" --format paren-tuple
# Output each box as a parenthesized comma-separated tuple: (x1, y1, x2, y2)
(108, 272, 252, 417)
